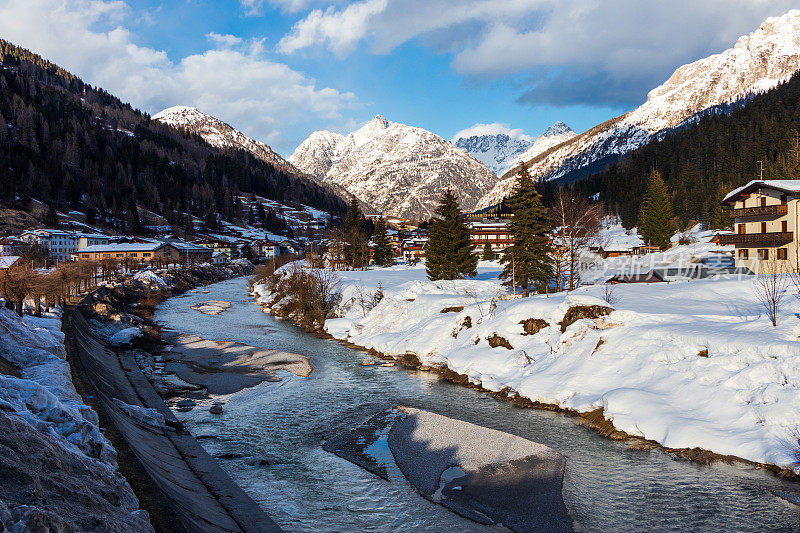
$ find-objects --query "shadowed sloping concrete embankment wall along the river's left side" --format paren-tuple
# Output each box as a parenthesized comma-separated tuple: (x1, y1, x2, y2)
(70, 310, 279, 532)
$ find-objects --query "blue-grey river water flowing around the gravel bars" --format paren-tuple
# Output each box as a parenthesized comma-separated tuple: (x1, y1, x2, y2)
(156, 278, 800, 532)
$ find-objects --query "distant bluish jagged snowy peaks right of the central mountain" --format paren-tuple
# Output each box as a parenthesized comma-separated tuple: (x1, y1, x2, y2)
(453, 122, 577, 176)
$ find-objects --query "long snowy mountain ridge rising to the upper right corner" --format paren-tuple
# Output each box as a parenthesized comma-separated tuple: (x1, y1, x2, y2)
(478, 9, 800, 208)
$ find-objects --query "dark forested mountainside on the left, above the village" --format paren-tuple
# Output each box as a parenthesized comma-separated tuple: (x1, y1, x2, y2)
(0, 40, 347, 231)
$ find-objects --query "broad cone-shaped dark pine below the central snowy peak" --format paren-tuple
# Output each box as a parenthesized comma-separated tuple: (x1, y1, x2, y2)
(425, 189, 478, 280)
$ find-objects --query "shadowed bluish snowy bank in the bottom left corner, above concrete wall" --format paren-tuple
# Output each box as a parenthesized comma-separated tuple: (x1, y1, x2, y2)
(0, 308, 153, 532)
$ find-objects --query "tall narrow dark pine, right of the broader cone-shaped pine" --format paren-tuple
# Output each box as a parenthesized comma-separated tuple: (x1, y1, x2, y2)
(500, 166, 553, 296)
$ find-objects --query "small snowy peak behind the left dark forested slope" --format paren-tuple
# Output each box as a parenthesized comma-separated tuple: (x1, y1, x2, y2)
(153, 106, 299, 173)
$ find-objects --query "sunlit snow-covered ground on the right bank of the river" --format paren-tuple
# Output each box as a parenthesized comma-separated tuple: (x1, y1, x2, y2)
(255, 258, 800, 470)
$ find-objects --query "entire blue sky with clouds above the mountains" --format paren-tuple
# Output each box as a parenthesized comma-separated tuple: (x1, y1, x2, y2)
(0, 0, 791, 156)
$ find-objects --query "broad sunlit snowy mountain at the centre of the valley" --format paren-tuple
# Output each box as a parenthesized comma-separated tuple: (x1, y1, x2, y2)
(289, 115, 497, 218)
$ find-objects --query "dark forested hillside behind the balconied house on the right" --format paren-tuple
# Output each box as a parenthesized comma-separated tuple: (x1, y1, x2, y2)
(576, 70, 800, 226)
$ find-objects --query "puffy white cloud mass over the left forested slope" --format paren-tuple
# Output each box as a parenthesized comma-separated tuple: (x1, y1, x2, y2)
(0, 0, 357, 151)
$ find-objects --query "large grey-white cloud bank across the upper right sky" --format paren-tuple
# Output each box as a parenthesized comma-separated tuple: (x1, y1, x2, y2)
(278, 0, 796, 102)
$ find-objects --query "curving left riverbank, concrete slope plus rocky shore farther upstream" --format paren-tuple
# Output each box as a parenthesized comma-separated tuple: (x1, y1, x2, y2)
(67, 261, 288, 532)
